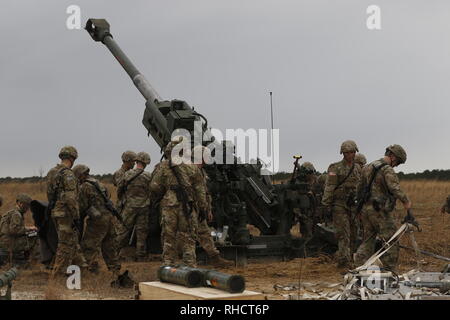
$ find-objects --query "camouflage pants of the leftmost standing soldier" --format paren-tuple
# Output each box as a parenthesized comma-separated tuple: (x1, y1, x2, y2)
(53, 217, 86, 274)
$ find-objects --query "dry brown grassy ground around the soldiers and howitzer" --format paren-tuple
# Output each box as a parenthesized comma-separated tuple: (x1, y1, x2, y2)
(0, 181, 450, 300)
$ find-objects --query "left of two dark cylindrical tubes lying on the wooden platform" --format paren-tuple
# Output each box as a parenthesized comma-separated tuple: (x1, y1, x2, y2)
(158, 266, 204, 288)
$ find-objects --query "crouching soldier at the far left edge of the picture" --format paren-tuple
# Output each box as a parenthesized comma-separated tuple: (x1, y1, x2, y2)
(0, 193, 37, 266)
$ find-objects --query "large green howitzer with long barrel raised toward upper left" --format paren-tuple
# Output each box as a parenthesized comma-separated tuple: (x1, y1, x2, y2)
(85, 19, 338, 262)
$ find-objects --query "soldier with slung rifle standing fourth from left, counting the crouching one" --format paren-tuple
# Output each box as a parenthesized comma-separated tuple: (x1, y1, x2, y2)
(117, 152, 152, 261)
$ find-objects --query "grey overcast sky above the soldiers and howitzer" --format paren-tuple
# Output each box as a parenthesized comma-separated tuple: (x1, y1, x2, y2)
(0, 0, 450, 177)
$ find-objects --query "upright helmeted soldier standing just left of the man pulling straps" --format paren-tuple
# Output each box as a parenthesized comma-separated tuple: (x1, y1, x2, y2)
(322, 140, 361, 268)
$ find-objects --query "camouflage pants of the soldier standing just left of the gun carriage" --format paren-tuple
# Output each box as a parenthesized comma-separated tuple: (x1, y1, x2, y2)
(118, 207, 150, 258)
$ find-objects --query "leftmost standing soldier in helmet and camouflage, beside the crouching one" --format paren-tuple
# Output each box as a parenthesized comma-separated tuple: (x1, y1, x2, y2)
(46, 146, 87, 274)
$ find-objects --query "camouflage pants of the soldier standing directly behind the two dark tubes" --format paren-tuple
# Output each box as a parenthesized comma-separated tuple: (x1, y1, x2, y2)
(161, 206, 198, 267)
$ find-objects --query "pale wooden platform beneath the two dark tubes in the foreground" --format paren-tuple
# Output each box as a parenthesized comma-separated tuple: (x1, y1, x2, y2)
(137, 281, 265, 300)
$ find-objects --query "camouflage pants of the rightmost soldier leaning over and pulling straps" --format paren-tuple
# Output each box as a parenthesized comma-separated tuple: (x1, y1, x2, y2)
(355, 206, 399, 270)
